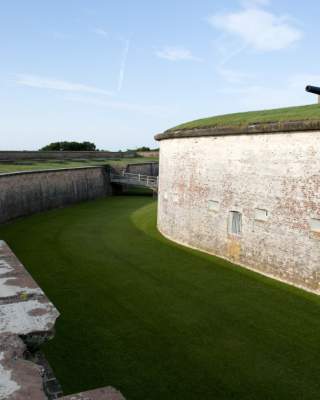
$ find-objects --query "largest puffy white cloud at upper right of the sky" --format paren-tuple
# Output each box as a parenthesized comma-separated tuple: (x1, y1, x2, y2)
(209, 0, 303, 51)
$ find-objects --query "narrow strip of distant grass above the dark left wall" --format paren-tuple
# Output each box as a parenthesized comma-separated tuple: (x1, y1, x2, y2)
(0, 157, 158, 174)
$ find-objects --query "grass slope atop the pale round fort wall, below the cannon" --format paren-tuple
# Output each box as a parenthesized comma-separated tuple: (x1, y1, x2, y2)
(169, 104, 320, 131)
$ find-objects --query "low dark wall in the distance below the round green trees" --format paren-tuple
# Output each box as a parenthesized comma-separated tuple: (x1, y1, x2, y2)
(0, 151, 136, 161)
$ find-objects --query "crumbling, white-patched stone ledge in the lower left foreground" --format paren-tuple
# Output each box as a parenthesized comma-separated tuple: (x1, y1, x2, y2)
(0, 240, 124, 400)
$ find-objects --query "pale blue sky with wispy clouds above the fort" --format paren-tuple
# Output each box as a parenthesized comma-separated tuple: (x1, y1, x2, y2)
(0, 0, 320, 150)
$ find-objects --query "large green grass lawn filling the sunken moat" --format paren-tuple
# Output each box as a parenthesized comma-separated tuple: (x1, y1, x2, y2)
(0, 196, 320, 400)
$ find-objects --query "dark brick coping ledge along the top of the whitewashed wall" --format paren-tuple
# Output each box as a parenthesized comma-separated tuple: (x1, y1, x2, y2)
(155, 120, 320, 141)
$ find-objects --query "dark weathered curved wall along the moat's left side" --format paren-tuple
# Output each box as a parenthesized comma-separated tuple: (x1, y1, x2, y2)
(0, 167, 112, 223)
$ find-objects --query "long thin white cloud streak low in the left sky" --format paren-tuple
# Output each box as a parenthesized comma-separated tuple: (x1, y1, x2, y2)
(16, 74, 113, 95)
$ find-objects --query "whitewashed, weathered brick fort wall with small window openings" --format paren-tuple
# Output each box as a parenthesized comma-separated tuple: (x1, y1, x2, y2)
(158, 131, 320, 293)
